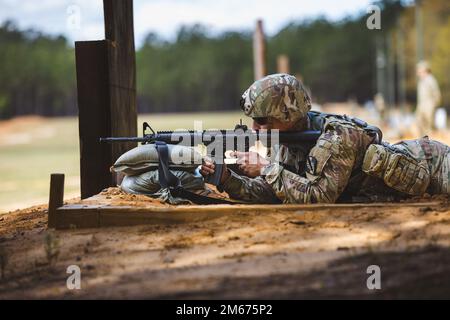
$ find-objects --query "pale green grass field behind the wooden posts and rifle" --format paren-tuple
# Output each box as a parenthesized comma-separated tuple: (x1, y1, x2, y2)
(0, 112, 248, 213)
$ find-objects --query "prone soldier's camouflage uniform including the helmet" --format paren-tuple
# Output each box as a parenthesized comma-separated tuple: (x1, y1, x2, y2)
(219, 75, 450, 203)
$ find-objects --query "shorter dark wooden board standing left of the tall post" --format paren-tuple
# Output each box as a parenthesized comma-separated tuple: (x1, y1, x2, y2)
(75, 40, 114, 199)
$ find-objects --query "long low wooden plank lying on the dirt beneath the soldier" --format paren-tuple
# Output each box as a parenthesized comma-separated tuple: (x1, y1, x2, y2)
(51, 202, 441, 229)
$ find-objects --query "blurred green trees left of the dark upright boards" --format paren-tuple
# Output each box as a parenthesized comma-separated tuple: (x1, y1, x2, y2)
(0, 21, 77, 118)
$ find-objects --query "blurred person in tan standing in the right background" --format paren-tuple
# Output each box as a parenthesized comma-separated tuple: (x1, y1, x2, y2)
(416, 61, 441, 136)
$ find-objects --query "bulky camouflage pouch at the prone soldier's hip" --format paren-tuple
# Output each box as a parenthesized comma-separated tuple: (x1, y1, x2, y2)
(362, 144, 431, 195)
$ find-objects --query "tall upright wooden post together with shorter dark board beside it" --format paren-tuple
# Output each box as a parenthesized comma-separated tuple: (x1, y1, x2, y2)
(75, 0, 137, 199)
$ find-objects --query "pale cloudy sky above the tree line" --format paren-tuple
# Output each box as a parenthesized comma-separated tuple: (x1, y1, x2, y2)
(0, 0, 372, 47)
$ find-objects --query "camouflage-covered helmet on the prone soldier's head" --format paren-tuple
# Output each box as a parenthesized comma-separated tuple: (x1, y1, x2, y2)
(241, 73, 311, 122)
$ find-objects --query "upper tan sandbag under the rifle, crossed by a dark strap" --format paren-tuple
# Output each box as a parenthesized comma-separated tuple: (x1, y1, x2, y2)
(111, 144, 202, 176)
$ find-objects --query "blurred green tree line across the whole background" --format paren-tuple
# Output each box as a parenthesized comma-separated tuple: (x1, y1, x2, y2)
(0, 0, 450, 118)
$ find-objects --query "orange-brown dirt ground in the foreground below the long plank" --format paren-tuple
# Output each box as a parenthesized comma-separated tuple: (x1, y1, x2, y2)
(0, 189, 450, 299)
